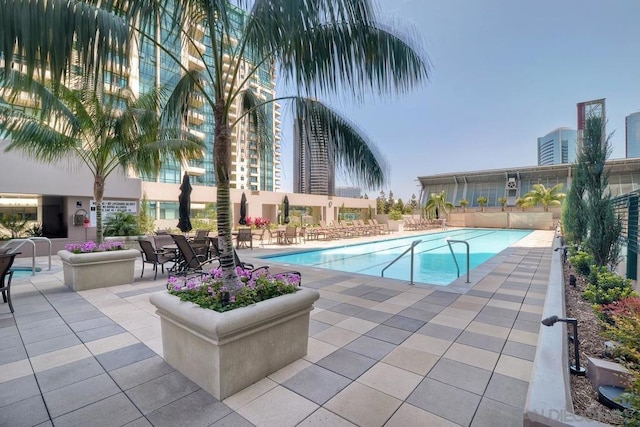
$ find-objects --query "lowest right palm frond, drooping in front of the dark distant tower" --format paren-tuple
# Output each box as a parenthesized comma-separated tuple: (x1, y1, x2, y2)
(293, 97, 388, 188)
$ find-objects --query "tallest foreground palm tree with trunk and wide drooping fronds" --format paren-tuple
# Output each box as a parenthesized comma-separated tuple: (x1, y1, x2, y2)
(0, 0, 428, 292)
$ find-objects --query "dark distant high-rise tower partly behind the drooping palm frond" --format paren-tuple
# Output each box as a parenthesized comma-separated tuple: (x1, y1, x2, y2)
(293, 113, 336, 196)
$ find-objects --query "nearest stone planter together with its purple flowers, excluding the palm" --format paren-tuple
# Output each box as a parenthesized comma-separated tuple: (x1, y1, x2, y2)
(150, 267, 319, 400)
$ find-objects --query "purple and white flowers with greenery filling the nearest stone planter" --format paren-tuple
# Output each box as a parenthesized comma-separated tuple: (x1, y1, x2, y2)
(167, 267, 300, 312)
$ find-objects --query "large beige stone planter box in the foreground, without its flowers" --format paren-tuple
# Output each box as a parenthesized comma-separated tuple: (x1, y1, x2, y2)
(150, 289, 319, 400)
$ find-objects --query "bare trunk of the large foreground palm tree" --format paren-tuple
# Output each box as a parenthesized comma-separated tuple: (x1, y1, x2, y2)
(213, 99, 241, 295)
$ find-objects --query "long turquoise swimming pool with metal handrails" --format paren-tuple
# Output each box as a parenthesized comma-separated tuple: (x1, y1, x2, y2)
(262, 228, 531, 285)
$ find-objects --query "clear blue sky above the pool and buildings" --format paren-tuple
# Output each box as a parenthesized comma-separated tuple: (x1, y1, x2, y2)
(282, 0, 640, 201)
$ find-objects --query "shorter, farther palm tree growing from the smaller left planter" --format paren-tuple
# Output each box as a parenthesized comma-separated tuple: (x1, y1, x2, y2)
(0, 71, 204, 243)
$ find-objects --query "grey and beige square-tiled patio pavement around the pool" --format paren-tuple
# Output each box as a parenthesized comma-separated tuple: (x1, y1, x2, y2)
(0, 231, 553, 427)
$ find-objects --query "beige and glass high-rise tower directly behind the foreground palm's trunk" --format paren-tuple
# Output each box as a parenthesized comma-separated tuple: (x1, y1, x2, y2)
(132, 8, 281, 191)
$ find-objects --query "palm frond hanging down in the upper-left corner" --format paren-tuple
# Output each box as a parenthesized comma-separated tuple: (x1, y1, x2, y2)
(0, 0, 130, 87)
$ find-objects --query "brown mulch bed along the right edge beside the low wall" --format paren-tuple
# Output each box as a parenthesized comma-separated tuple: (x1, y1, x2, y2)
(564, 261, 623, 425)
